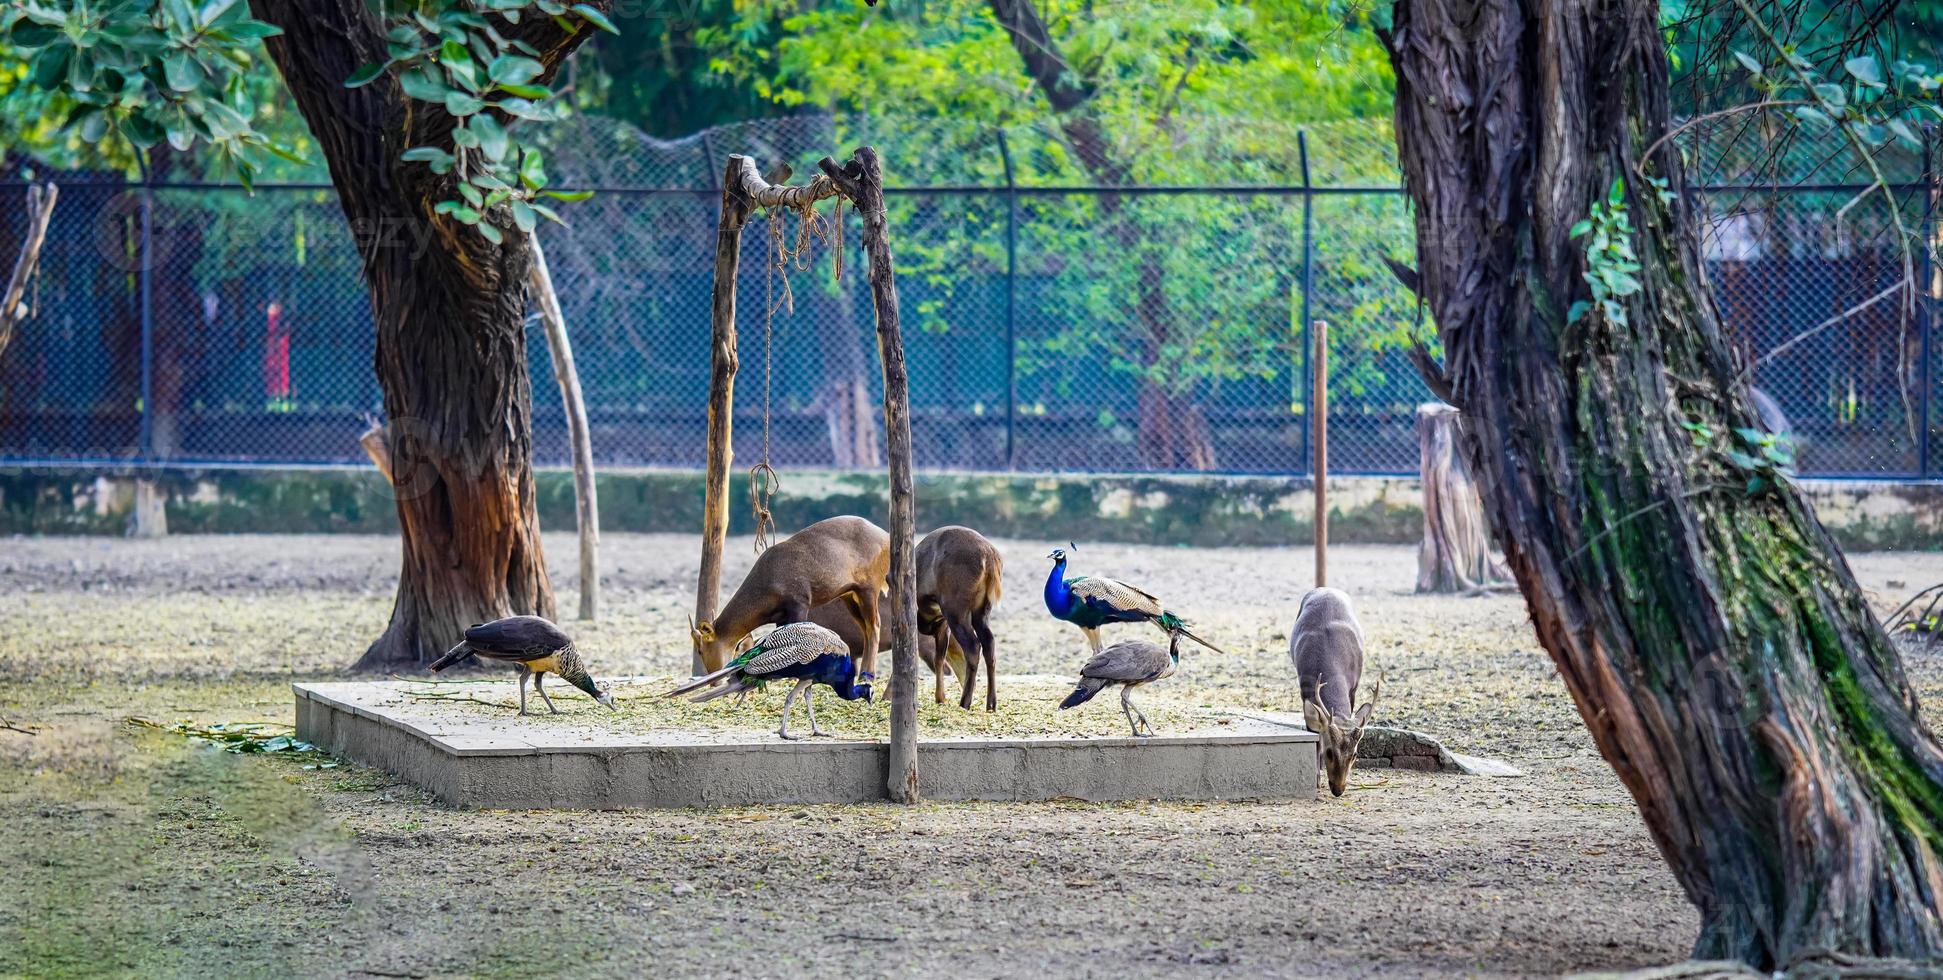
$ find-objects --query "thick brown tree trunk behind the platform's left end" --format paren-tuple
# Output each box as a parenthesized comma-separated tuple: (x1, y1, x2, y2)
(251, 0, 606, 671)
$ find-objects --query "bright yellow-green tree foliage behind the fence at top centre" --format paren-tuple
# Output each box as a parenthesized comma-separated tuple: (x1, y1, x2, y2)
(694, 0, 1416, 418)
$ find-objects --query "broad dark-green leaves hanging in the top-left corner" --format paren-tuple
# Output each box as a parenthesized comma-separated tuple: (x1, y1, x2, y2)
(0, 0, 295, 185)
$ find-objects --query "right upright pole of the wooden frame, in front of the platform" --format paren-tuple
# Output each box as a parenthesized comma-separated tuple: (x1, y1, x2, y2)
(818, 146, 921, 803)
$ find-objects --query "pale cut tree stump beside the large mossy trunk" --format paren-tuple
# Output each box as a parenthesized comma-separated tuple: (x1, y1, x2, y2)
(1416, 403, 1508, 593)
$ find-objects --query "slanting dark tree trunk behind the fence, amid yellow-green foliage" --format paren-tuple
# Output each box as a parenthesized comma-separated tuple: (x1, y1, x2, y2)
(991, 0, 1216, 471)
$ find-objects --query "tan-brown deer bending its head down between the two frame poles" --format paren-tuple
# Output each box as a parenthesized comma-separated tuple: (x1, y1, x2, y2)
(688, 517, 890, 681)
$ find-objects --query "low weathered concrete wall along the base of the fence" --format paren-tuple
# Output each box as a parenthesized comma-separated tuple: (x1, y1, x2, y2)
(0, 469, 1943, 550)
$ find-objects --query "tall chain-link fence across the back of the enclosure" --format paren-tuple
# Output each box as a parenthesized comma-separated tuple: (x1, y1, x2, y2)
(0, 117, 1943, 478)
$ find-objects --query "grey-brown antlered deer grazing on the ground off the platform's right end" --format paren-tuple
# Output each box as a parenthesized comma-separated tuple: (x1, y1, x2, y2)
(1288, 589, 1383, 795)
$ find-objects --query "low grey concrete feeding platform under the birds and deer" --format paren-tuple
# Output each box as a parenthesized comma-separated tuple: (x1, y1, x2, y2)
(291, 681, 1315, 809)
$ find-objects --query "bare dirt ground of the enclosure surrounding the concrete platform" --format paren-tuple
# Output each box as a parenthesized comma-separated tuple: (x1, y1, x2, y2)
(0, 535, 1943, 978)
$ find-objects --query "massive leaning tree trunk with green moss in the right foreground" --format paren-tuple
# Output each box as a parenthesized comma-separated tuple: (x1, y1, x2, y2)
(1385, 0, 1943, 970)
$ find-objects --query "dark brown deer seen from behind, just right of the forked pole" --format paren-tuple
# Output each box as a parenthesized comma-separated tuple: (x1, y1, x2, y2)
(917, 525, 1005, 712)
